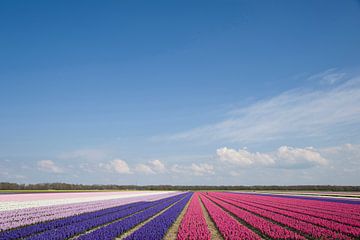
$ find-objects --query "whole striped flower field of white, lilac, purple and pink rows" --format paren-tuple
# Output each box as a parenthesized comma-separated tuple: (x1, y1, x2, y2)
(0, 191, 360, 240)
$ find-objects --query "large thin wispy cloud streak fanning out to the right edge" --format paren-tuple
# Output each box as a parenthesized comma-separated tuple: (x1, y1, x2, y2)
(165, 73, 360, 144)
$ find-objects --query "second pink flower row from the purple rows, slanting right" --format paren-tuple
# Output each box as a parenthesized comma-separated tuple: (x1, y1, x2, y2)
(198, 195, 261, 240)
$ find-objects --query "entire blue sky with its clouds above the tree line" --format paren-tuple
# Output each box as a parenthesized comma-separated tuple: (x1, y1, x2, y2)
(0, 0, 360, 185)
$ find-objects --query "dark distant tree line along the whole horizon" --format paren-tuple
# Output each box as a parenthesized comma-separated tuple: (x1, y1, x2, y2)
(0, 182, 360, 191)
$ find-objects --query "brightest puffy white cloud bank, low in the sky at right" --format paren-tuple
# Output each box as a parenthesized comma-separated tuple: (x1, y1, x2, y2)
(216, 146, 328, 168)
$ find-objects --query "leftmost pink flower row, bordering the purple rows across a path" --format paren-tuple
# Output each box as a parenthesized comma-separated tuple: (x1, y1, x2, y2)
(177, 192, 211, 240)
